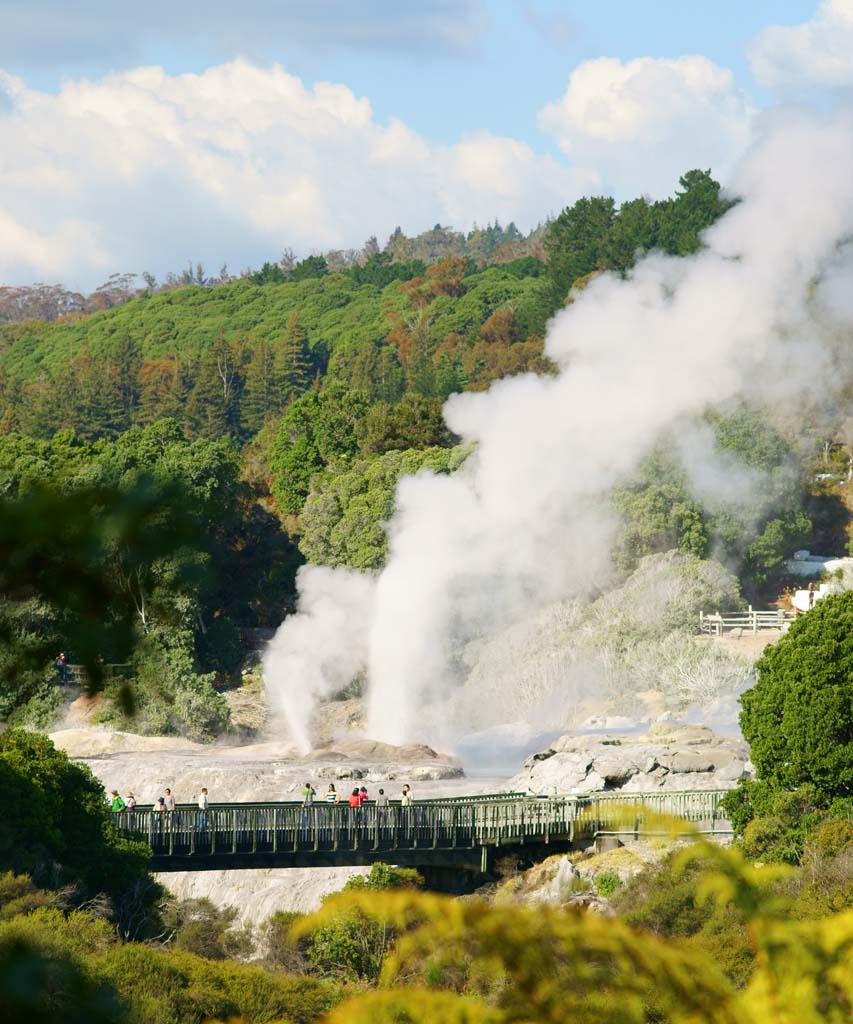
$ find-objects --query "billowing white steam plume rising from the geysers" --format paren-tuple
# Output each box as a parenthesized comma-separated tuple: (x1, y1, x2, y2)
(265, 113, 853, 744)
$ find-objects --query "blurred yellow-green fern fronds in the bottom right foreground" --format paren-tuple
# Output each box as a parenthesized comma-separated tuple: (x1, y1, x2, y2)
(294, 844, 853, 1024)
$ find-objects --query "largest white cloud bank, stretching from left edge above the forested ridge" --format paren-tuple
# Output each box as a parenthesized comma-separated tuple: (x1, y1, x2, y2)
(0, 60, 596, 286)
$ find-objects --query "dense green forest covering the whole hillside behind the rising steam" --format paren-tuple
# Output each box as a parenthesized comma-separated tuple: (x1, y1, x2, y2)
(0, 170, 843, 738)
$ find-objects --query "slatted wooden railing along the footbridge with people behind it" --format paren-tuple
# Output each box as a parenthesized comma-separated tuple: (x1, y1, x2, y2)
(114, 791, 728, 858)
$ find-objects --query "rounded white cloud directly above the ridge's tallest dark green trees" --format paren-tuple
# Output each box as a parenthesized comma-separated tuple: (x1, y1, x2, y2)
(540, 56, 755, 196)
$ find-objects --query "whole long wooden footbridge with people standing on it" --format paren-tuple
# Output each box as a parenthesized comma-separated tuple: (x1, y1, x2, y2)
(114, 790, 732, 872)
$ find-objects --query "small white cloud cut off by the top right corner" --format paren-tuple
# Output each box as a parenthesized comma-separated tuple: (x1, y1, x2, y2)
(749, 0, 853, 93)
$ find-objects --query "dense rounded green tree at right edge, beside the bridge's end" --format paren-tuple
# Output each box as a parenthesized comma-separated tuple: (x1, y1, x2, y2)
(740, 592, 853, 799)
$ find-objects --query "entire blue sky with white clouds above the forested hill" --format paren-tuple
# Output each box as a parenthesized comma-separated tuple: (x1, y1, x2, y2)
(0, 0, 853, 290)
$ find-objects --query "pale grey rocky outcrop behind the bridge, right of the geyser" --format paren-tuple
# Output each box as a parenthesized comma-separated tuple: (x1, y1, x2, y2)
(506, 722, 752, 794)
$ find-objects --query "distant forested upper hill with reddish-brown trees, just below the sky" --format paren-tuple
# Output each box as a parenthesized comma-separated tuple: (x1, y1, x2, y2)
(0, 171, 725, 443)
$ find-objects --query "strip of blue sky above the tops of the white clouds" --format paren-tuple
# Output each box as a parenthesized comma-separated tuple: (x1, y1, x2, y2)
(0, 0, 816, 147)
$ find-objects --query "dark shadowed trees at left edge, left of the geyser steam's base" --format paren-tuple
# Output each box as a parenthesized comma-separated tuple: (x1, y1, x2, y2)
(0, 420, 299, 724)
